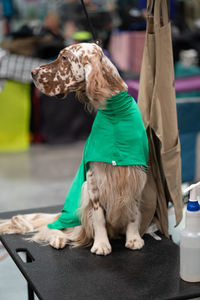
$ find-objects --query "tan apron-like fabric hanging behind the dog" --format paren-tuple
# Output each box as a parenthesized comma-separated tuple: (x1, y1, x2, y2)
(138, 0, 183, 236)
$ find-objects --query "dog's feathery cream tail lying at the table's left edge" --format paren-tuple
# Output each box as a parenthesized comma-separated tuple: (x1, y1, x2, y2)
(0, 213, 60, 234)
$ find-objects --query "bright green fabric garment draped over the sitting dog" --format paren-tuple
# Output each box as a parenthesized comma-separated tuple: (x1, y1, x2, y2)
(48, 92, 148, 229)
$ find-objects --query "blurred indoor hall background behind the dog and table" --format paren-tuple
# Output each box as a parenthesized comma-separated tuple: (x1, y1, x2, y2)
(0, 0, 200, 300)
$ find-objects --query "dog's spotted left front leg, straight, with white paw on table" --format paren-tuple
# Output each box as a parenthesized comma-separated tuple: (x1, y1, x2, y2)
(87, 170, 111, 255)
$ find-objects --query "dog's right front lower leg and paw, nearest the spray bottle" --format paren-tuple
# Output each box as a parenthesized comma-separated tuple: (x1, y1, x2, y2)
(125, 207, 144, 250)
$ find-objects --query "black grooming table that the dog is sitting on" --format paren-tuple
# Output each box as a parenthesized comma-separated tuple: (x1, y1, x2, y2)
(0, 207, 200, 300)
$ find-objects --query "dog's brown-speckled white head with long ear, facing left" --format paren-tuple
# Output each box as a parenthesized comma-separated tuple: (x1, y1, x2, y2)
(32, 43, 126, 106)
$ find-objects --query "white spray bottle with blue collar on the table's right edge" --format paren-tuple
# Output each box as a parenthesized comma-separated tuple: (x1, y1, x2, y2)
(180, 182, 200, 282)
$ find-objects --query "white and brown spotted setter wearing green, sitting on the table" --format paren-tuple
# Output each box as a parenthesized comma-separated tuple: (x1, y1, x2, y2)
(0, 43, 146, 255)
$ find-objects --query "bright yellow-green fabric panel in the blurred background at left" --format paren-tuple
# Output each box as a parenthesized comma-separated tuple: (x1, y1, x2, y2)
(0, 80, 31, 152)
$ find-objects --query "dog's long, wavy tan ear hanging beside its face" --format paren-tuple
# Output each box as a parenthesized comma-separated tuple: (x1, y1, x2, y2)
(85, 50, 110, 108)
